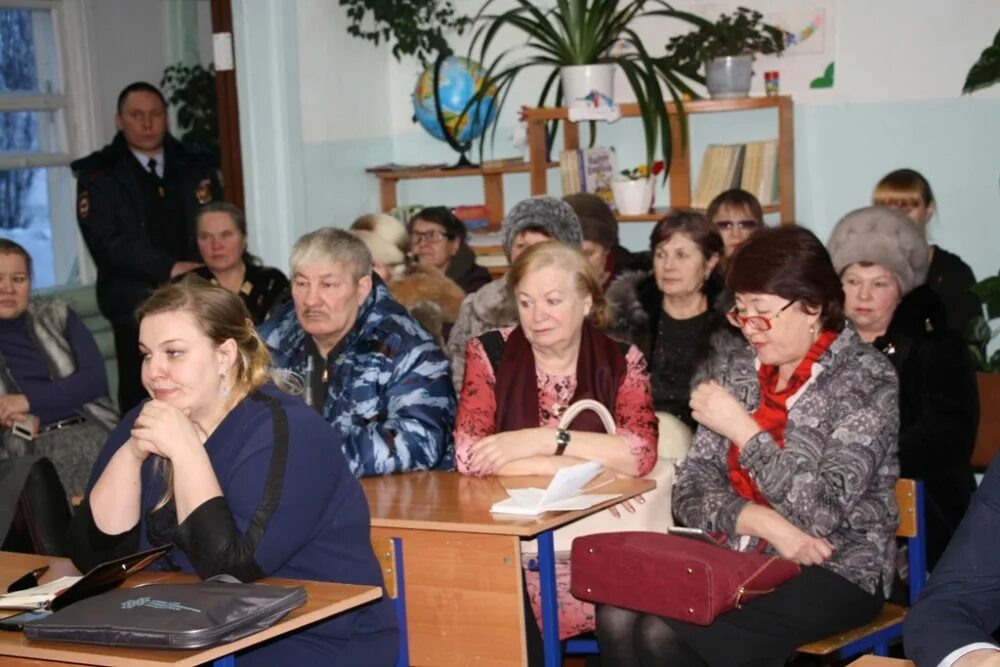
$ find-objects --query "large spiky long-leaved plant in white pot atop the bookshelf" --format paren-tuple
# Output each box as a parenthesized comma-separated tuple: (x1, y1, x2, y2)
(467, 0, 710, 178)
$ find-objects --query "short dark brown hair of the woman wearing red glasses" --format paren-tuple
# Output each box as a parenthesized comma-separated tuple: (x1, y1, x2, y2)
(726, 225, 844, 331)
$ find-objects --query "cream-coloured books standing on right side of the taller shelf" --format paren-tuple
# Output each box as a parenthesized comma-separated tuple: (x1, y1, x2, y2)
(691, 139, 779, 209)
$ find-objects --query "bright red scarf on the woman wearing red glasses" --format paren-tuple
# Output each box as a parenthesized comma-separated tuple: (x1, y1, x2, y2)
(728, 331, 837, 507)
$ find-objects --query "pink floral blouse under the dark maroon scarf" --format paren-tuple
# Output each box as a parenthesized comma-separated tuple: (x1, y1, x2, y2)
(455, 327, 658, 476)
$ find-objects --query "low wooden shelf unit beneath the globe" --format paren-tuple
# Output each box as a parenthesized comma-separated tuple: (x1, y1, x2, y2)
(367, 160, 559, 229)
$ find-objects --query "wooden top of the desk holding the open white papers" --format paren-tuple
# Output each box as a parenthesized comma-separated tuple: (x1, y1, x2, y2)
(361, 471, 656, 537)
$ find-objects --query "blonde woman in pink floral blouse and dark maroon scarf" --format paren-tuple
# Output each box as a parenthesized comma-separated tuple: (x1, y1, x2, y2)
(455, 241, 667, 637)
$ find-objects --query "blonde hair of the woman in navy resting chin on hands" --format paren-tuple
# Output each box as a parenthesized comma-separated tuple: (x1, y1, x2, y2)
(135, 276, 271, 511)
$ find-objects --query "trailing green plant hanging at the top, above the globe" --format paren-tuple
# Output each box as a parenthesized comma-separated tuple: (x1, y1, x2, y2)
(340, 0, 472, 67)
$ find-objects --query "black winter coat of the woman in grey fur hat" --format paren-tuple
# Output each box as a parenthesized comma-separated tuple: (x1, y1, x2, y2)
(874, 285, 979, 568)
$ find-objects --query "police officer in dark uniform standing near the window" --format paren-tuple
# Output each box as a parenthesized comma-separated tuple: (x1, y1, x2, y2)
(71, 82, 219, 414)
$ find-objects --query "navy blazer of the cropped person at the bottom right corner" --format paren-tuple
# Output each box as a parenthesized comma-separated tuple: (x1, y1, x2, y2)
(903, 461, 1000, 667)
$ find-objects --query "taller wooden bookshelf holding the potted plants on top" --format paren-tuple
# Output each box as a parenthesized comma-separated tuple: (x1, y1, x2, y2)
(520, 95, 795, 224)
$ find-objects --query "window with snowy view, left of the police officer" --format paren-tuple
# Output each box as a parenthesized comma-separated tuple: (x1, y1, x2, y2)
(0, 0, 79, 288)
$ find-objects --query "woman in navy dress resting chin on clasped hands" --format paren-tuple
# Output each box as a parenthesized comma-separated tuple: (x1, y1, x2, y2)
(70, 281, 397, 665)
